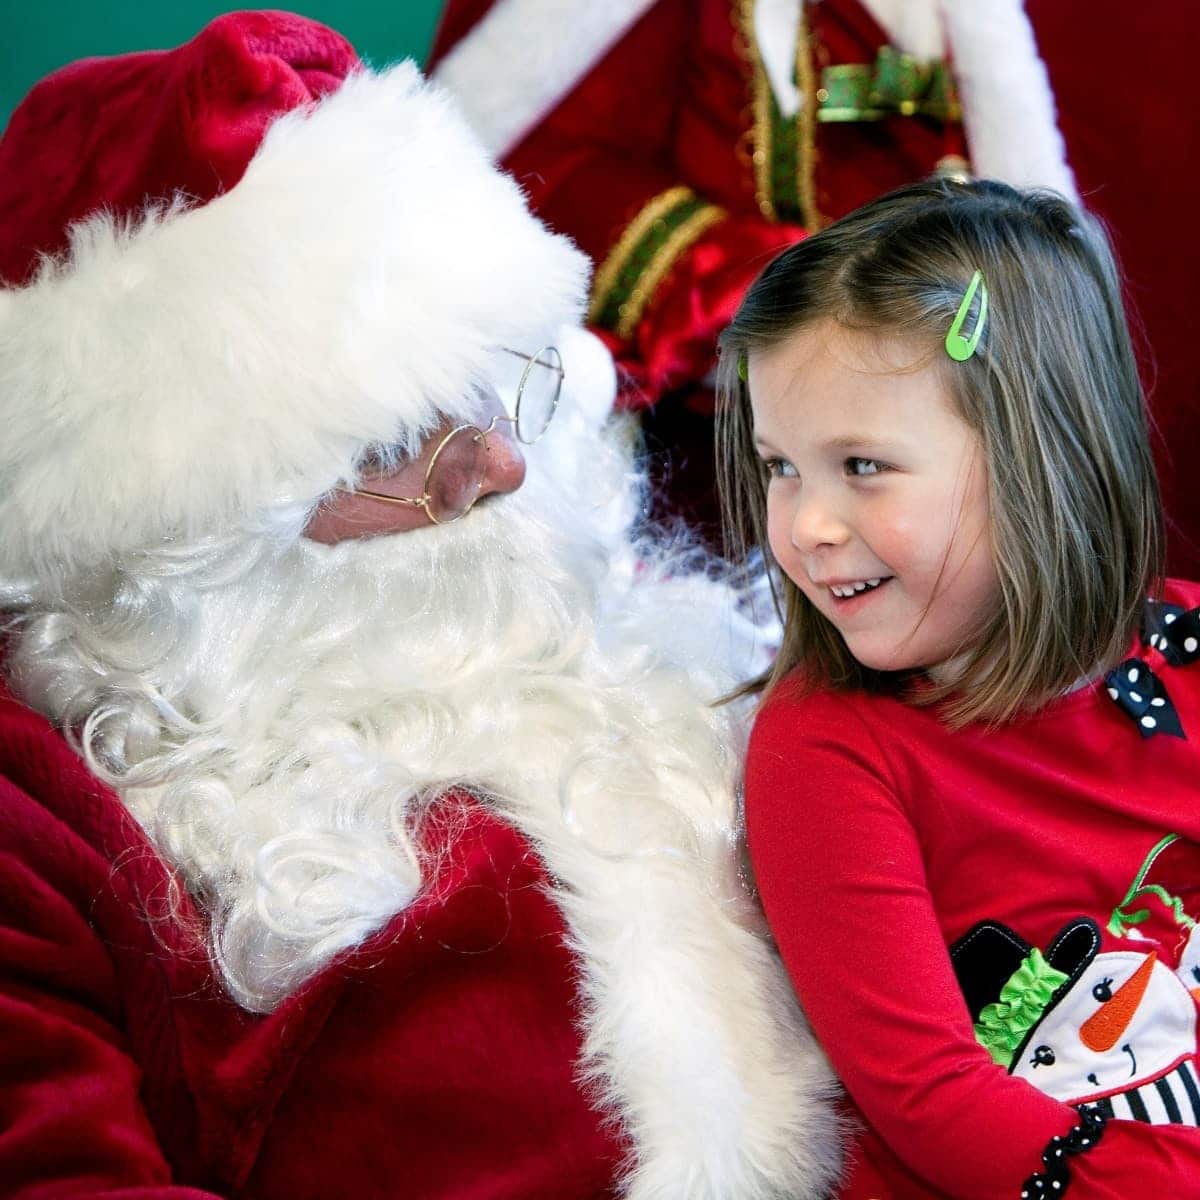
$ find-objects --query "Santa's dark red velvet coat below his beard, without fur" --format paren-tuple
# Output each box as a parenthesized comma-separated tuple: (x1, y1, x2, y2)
(0, 698, 625, 1200)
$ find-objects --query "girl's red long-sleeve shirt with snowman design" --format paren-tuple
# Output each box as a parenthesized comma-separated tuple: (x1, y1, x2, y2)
(745, 583, 1200, 1200)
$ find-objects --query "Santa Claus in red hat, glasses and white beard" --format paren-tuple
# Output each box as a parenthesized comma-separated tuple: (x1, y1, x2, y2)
(0, 12, 838, 1200)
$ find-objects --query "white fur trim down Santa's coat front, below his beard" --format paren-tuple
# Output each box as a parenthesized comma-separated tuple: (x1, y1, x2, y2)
(532, 792, 840, 1200)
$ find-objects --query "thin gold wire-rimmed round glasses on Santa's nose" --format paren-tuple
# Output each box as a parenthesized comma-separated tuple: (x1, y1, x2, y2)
(343, 346, 565, 524)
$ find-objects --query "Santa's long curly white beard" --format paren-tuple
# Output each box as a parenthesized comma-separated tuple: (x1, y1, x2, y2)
(14, 417, 763, 1010)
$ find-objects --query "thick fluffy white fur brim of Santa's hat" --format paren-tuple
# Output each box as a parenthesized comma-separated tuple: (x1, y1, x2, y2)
(0, 64, 588, 577)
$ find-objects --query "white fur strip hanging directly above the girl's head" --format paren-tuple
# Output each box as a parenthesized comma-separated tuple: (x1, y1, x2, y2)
(942, 0, 1079, 200)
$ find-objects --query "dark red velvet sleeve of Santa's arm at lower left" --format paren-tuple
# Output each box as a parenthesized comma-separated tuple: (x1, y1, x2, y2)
(0, 779, 220, 1200)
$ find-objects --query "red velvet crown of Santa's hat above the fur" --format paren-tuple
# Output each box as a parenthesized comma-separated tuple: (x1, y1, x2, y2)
(0, 12, 359, 286)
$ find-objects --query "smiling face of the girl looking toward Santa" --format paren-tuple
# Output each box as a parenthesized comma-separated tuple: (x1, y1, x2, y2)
(749, 322, 1000, 682)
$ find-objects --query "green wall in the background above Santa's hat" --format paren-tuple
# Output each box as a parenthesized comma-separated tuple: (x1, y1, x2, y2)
(0, 0, 442, 125)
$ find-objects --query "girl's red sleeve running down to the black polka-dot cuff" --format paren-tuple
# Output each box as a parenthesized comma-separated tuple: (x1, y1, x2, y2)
(746, 697, 1200, 1200)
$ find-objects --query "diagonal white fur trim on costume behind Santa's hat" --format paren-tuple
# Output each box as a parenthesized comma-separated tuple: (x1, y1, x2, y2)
(433, 0, 654, 158)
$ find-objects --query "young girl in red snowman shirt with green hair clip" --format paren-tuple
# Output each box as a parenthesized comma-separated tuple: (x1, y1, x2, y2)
(720, 182, 1200, 1200)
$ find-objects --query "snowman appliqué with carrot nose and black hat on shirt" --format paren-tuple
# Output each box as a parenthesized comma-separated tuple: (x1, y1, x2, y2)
(950, 835, 1200, 1126)
